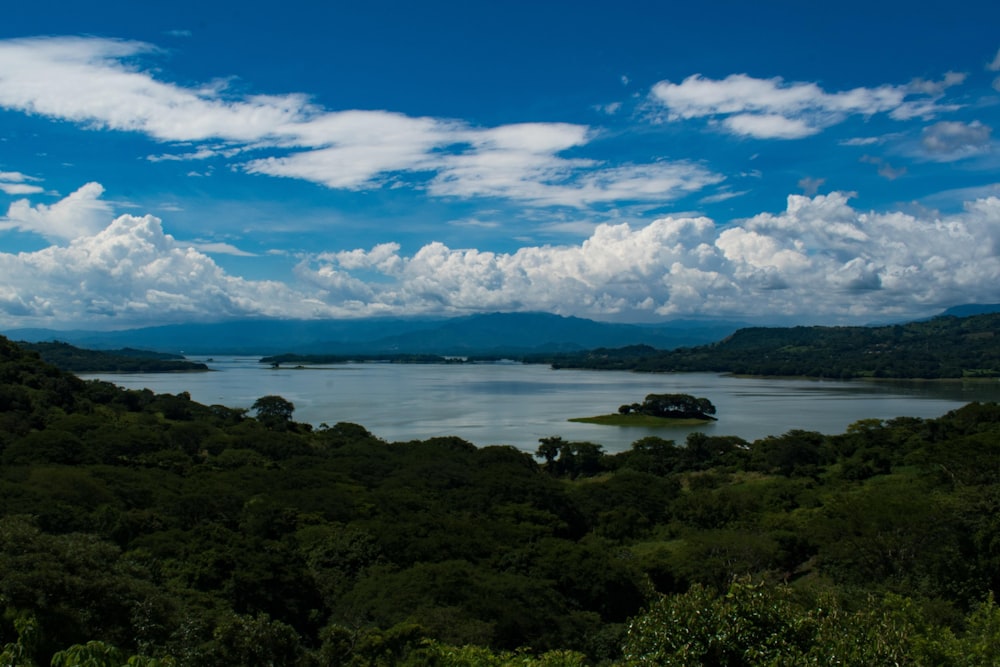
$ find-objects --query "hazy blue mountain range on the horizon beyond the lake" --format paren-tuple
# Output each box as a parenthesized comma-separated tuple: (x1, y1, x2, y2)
(5, 313, 740, 355)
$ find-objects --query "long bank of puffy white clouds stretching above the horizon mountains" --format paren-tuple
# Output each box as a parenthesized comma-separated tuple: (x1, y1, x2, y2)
(0, 184, 1000, 327)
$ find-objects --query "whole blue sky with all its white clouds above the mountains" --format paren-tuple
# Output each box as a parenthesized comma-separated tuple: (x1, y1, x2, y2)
(0, 0, 1000, 330)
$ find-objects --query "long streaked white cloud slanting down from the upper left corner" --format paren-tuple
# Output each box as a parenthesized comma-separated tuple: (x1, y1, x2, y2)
(0, 38, 721, 207)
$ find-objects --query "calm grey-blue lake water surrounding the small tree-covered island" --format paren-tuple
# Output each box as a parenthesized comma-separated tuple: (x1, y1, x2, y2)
(81, 357, 1000, 452)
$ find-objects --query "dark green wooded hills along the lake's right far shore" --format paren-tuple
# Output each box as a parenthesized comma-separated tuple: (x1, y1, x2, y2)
(526, 313, 1000, 379)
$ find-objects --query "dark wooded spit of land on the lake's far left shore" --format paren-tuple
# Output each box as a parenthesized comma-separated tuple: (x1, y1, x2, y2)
(18, 341, 208, 373)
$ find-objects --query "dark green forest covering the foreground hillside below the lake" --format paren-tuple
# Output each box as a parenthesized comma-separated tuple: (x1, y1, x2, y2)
(0, 337, 1000, 667)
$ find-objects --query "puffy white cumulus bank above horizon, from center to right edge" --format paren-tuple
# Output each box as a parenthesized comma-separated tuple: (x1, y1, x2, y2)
(297, 193, 1000, 321)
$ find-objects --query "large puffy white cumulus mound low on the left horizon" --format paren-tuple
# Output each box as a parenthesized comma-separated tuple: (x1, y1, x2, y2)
(0, 207, 313, 326)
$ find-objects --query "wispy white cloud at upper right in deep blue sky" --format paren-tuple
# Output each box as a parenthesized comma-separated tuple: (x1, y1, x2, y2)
(650, 72, 965, 139)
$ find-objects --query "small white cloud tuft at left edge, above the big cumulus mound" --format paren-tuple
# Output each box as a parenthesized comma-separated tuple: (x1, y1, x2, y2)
(0, 183, 111, 241)
